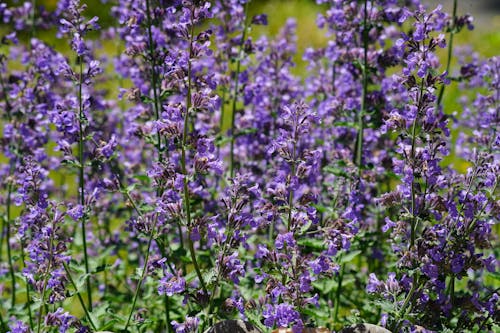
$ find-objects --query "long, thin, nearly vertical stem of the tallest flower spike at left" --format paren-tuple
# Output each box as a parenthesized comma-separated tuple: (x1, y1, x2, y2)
(78, 57, 92, 312)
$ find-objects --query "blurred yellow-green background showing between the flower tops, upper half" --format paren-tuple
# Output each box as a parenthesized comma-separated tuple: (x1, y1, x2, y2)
(4, 0, 500, 171)
